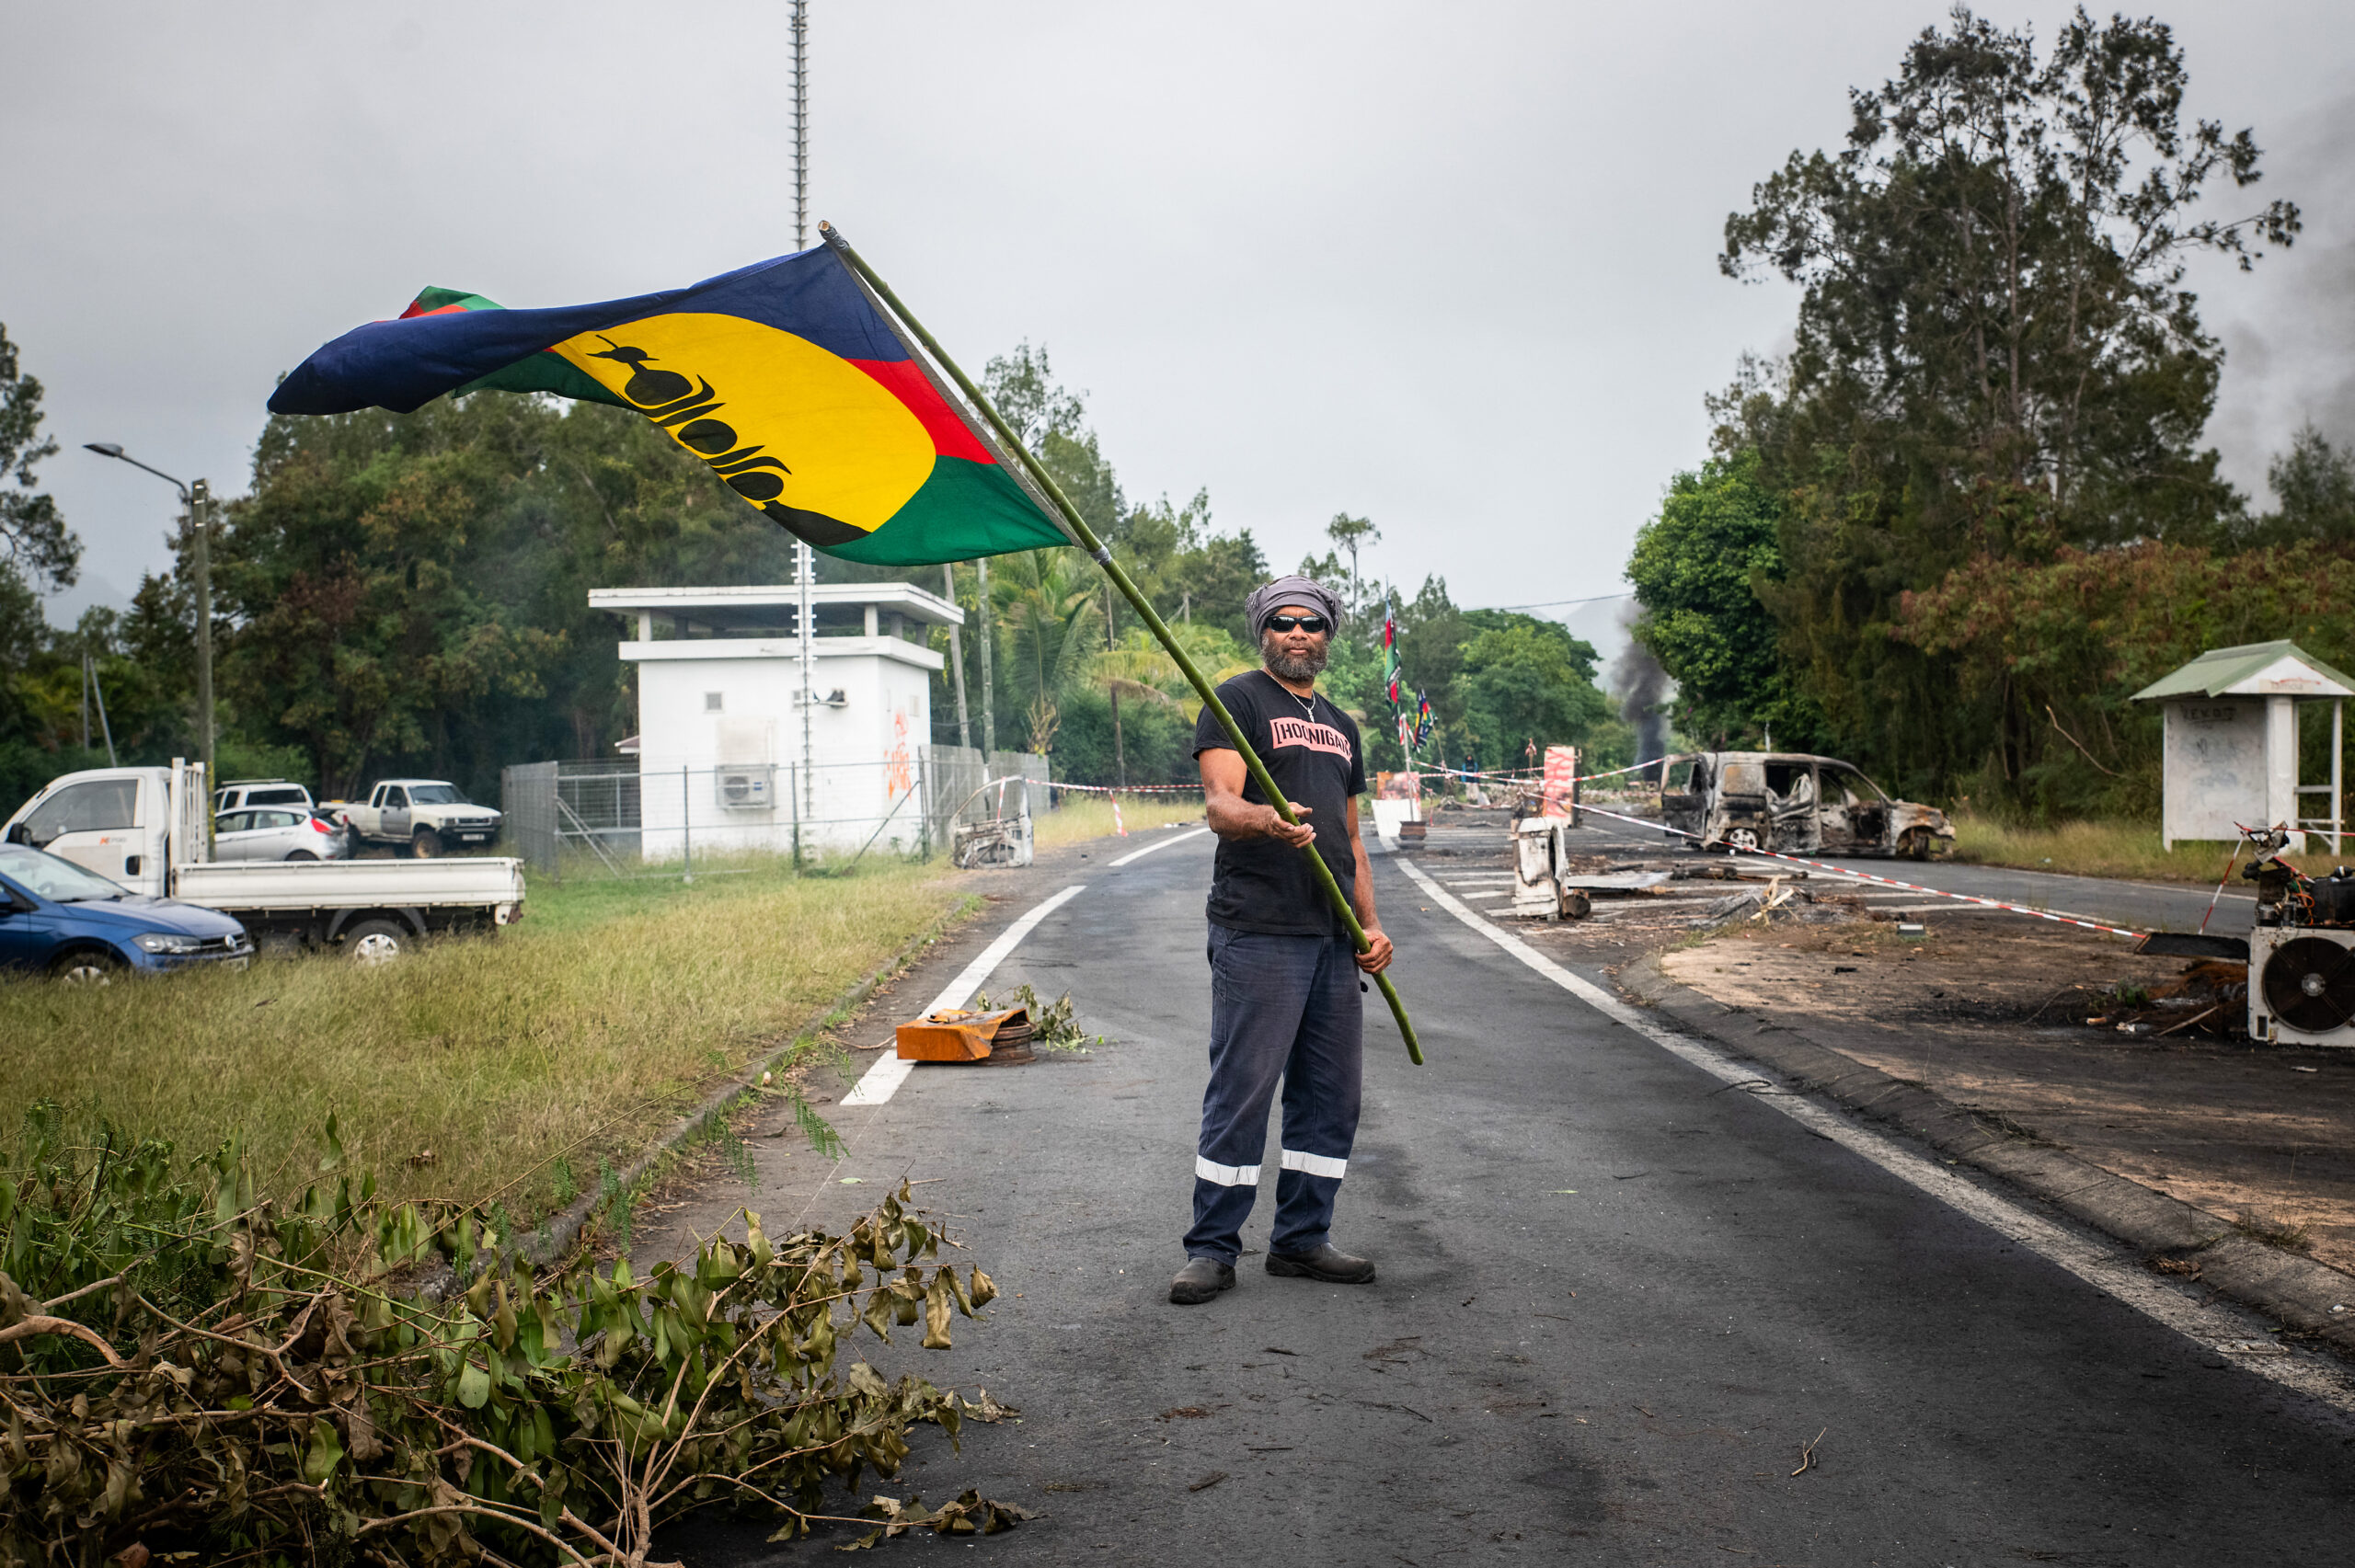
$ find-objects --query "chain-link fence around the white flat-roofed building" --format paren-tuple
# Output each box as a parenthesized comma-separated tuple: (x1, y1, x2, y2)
(500, 747, 1055, 878)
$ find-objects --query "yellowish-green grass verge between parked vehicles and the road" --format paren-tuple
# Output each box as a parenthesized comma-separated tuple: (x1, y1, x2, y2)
(0, 862, 968, 1224)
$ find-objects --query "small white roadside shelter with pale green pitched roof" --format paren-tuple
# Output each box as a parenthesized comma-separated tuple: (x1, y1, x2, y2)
(2133, 640, 2355, 854)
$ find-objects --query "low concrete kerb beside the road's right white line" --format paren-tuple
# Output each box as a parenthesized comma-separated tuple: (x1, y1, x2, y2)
(1615, 958, 2355, 1351)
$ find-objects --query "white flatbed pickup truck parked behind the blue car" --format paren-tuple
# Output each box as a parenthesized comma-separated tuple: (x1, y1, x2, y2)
(0, 761, 523, 963)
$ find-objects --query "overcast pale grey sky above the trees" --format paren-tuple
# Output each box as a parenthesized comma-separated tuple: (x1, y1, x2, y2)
(0, 0, 2355, 619)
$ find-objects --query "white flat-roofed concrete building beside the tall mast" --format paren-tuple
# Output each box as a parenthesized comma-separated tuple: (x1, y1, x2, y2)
(589, 581, 966, 862)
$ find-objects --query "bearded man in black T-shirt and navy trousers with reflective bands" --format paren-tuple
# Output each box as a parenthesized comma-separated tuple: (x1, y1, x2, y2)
(1170, 577, 1389, 1307)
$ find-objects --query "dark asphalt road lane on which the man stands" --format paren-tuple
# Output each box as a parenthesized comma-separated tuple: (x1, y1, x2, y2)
(672, 838, 2355, 1568)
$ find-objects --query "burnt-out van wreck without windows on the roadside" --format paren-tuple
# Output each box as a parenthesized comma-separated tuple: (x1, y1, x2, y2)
(1656, 751, 1955, 859)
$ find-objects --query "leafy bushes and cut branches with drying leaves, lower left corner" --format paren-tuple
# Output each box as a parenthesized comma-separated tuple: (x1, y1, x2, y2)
(0, 1106, 1025, 1565)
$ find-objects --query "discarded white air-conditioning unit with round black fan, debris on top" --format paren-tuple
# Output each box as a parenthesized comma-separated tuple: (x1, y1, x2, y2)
(2242, 827, 2355, 1046)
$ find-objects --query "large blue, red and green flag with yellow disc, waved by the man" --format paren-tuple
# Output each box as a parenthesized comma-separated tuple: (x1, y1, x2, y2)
(270, 245, 1072, 565)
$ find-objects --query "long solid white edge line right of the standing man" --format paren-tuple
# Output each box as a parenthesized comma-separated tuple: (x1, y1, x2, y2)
(1399, 859, 2355, 1413)
